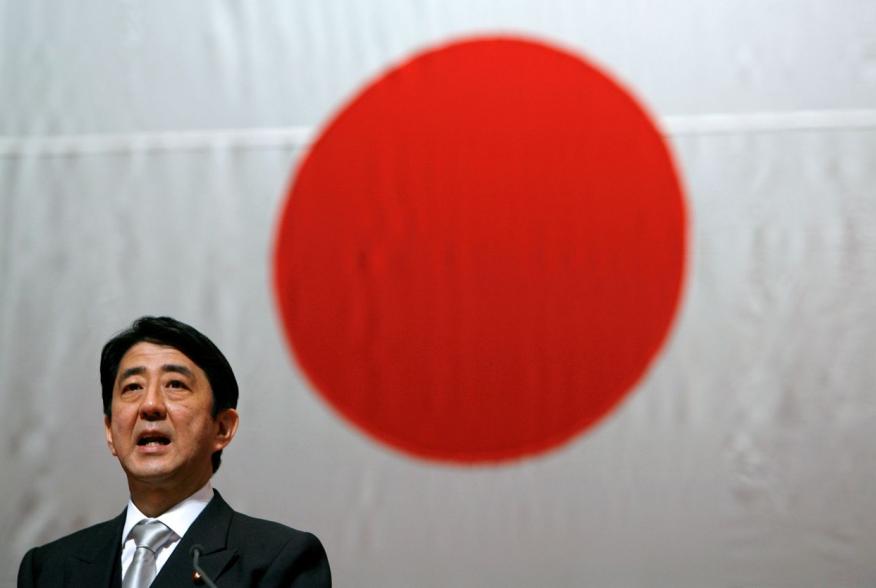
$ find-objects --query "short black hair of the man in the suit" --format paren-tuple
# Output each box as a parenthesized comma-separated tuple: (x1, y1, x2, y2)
(100, 316, 239, 473)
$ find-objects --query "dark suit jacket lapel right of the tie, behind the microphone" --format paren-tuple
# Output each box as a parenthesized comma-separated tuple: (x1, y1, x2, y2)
(152, 490, 237, 588)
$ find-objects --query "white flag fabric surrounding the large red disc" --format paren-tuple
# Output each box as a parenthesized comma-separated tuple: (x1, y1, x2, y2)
(0, 0, 876, 588)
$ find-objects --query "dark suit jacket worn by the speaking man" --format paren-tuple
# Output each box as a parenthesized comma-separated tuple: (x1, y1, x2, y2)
(18, 492, 331, 588)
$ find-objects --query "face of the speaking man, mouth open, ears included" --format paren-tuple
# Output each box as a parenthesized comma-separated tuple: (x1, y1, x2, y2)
(104, 342, 237, 492)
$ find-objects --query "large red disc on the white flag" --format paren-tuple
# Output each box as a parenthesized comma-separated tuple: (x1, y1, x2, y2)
(274, 38, 686, 462)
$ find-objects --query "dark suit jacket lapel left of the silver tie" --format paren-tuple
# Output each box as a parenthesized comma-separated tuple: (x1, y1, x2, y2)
(65, 510, 126, 588)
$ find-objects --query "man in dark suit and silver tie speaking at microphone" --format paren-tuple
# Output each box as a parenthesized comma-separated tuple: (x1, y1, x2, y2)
(18, 317, 331, 588)
